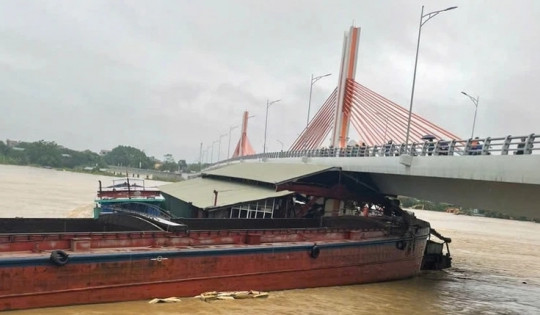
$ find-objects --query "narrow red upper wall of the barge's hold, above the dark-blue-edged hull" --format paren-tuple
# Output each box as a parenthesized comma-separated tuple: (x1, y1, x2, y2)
(0, 228, 386, 254)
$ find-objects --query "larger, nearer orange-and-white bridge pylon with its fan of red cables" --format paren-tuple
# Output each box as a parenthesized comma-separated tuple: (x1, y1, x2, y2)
(289, 26, 461, 151)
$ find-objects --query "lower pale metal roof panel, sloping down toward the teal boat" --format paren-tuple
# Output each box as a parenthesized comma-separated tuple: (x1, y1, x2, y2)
(160, 178, 292, 209)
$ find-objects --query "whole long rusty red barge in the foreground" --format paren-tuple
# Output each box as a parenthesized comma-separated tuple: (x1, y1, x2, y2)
(0, 215, 430, 310)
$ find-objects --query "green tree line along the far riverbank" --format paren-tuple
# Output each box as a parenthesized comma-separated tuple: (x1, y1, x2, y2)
(0, 140, 207, 172)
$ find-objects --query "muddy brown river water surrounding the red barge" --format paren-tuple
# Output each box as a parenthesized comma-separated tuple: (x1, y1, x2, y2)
(0, 165, 540, 315)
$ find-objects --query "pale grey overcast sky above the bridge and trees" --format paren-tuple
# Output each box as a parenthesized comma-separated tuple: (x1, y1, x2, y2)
(0, 0, 540, 162)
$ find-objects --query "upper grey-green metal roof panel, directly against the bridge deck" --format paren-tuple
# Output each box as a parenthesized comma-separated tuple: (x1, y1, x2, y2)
(203, 163, 337, 184)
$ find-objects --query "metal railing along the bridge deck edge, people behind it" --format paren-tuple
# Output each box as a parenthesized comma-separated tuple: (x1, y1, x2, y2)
(217, 133, 540, 164)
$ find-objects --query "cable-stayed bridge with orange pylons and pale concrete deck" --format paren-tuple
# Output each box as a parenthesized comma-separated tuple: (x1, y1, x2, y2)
(213, 27, 540, 218)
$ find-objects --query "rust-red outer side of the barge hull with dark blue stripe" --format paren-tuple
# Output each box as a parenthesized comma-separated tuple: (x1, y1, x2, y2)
(0, 228, 426, 310)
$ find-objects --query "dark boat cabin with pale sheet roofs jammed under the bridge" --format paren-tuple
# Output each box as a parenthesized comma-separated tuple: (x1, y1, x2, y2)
(160, 163, 395, 219)
